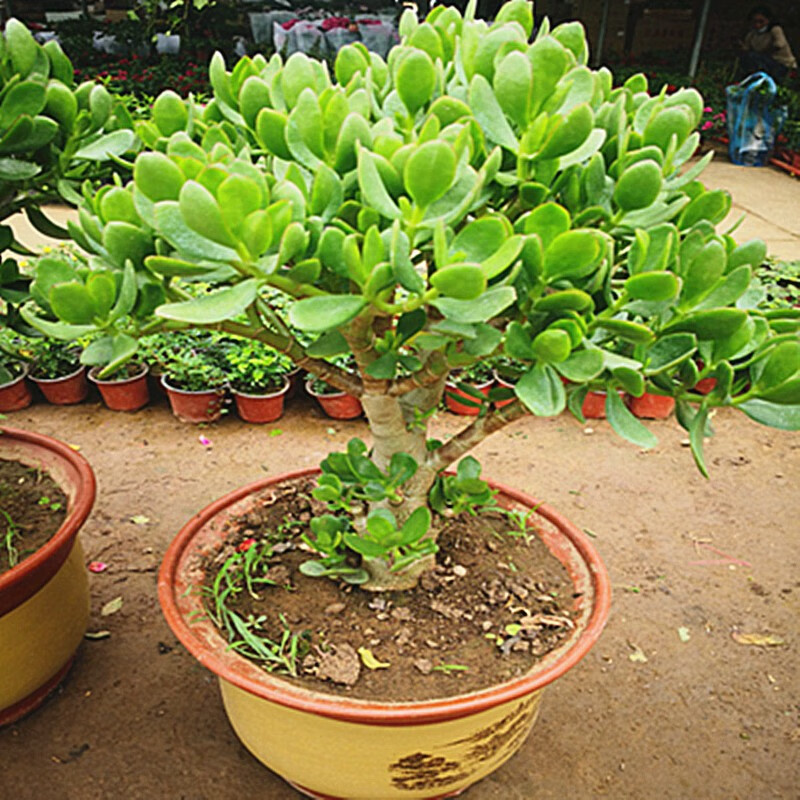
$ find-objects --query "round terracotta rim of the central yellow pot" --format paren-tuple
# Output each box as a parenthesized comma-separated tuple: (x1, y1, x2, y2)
(158, 468, 611, 725)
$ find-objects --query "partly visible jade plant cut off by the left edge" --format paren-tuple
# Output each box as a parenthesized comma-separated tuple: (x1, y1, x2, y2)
(0, 19, 136, 329)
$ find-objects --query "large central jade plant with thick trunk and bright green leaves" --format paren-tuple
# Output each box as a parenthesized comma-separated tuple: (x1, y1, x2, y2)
(24, 0, 800, 590)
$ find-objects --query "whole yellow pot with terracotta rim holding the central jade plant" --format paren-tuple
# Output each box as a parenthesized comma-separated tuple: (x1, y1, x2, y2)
(158, 470, 610, 800)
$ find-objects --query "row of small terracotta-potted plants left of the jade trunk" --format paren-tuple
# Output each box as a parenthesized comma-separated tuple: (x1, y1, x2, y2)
(0, 333, 362, 423)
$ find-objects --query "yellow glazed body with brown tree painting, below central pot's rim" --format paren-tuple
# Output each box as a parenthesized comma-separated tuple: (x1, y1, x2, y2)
(220, 679, 541, 800)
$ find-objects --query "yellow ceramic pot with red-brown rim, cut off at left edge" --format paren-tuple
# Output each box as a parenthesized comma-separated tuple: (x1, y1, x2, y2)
(0, 428, 95, 725)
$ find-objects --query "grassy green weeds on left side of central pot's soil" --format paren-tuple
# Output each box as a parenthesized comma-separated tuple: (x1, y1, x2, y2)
(207, 542, 308, 676)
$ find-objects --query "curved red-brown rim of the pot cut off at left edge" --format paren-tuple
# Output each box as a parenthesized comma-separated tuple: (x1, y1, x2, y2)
(0, 426, 97, 616)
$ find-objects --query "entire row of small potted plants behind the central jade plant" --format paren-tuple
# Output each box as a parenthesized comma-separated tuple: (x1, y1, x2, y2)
(0, 333, 713, 423)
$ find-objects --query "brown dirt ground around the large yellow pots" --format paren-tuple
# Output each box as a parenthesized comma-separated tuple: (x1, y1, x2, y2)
(0, 384, 800, 800)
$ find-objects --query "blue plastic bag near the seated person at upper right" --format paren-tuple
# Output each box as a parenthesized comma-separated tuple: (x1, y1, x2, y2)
(725, 72, 788, 167)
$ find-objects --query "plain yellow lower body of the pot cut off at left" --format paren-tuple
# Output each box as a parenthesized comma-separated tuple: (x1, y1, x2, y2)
(0, 540, 89, 709)
